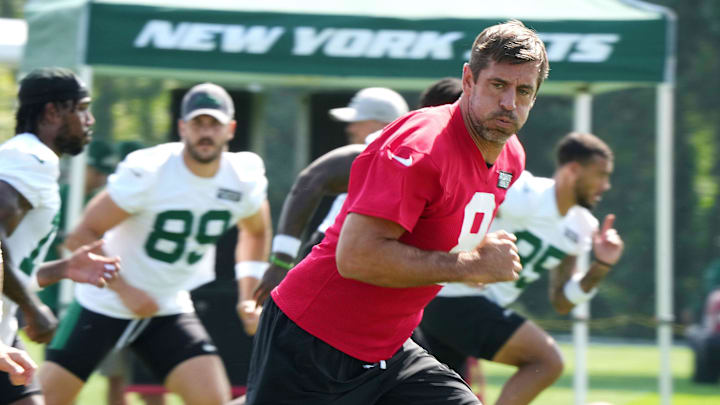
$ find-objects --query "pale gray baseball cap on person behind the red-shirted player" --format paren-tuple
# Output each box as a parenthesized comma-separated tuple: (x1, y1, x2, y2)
(329, 87, 408, 122)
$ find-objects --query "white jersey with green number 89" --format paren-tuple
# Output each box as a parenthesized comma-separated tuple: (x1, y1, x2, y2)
(75, 143, 267, 319)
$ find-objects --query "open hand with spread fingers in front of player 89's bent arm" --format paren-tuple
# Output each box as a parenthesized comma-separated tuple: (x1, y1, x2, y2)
(67, 240, 120, 288)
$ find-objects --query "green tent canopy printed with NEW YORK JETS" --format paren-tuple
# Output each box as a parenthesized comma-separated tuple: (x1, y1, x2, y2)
(24, 0, 674, 93)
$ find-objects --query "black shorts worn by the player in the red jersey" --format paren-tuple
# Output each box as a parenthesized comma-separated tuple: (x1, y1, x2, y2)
(246, 299, 480, 405)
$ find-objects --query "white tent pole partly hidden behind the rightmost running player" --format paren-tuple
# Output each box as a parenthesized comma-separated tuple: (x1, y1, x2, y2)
(572, 90, 593, 405)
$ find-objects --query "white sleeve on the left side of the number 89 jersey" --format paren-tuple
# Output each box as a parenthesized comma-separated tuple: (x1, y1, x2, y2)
(107, 150, 155, 214)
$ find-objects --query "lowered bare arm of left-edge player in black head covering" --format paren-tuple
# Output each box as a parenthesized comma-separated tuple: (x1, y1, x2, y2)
(0, 180, 57, 343)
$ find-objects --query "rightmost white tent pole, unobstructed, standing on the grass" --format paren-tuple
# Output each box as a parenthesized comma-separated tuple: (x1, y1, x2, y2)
(655, 83, 675, 405)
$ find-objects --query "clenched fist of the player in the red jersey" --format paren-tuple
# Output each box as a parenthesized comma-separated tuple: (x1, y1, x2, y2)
(461, 231, 522, 284)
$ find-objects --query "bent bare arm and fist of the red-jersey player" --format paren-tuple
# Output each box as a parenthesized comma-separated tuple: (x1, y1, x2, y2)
(336, 213, 522, 287)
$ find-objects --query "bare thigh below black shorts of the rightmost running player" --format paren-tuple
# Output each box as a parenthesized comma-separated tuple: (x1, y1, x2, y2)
(492, 320, 563, 367)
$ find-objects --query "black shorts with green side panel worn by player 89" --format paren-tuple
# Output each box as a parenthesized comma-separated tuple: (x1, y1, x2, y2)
(45, 302, 217, 381)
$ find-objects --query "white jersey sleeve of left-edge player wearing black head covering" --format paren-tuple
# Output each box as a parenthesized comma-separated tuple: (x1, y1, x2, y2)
(0, 149, 57, 207)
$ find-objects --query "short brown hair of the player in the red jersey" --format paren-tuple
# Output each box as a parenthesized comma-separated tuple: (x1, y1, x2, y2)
(470, 20, 550, 93)
